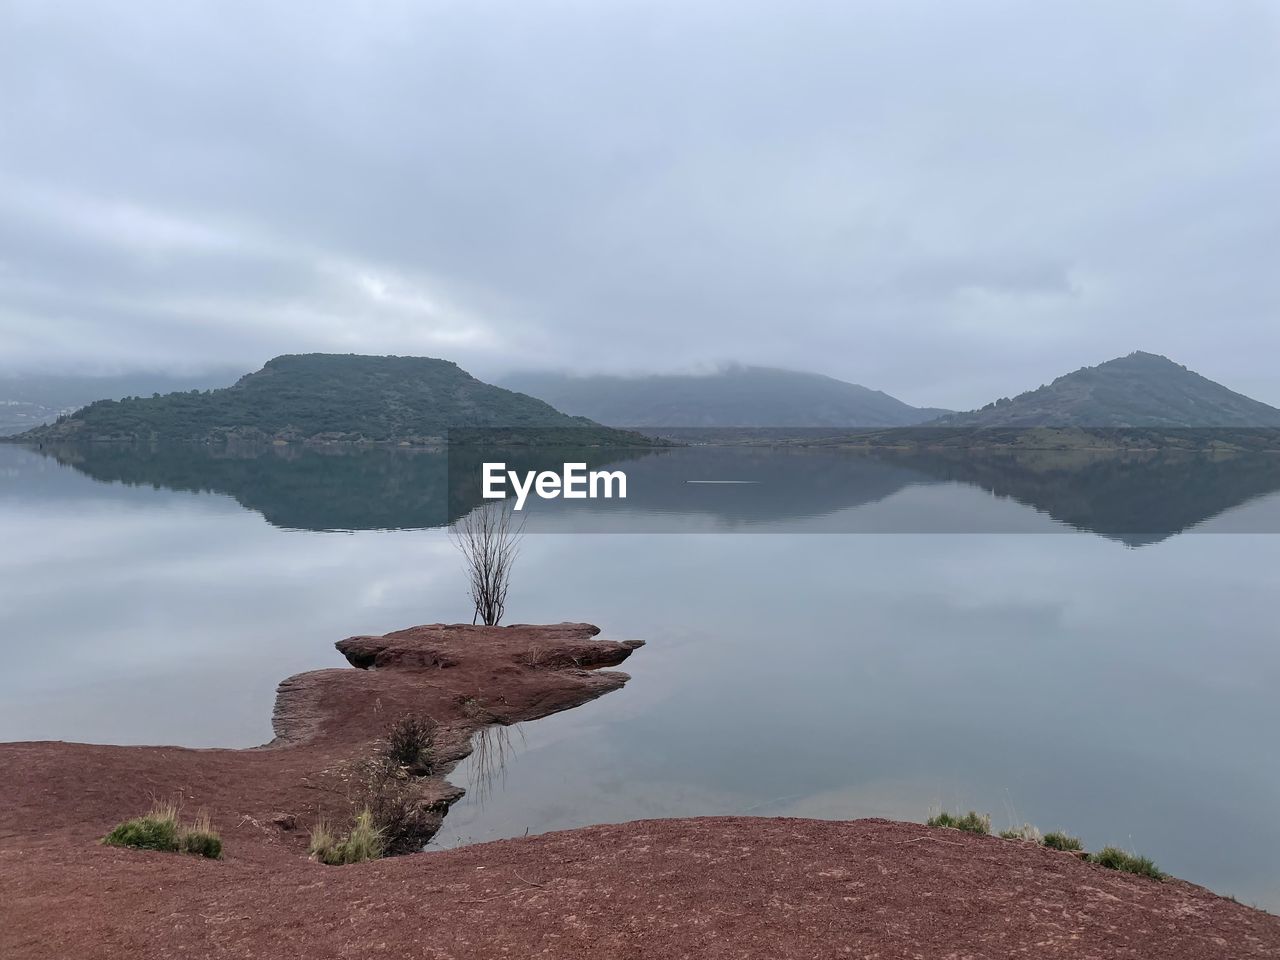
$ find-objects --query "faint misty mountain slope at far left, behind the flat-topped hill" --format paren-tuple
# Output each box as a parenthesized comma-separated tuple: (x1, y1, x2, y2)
(0, 371, 238, 436)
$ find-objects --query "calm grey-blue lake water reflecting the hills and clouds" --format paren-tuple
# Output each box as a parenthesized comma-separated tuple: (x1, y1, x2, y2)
(0, 445, 1280, 910)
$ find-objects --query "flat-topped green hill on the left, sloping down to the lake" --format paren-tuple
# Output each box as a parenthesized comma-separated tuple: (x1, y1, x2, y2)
(11, 353, 644, 443)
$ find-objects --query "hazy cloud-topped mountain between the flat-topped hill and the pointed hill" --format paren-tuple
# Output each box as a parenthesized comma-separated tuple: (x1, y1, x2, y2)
(499, 366, 946, 428)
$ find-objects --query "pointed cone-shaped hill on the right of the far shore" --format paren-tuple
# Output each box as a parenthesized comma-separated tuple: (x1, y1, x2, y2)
(931, 352, 1280, 428)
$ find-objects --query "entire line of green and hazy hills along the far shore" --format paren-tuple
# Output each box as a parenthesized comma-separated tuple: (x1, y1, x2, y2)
(5, 351, 1280, 444)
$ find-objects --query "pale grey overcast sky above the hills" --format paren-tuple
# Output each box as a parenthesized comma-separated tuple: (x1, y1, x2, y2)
(0, 0, 1280, 407)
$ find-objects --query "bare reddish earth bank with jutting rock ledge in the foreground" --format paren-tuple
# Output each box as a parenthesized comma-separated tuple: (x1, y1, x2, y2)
(0, 625, 1280, 960)
